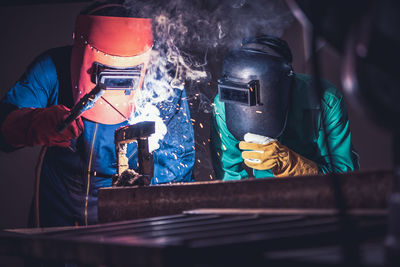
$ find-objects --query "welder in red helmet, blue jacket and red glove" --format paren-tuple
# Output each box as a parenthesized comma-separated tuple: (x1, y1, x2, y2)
(0, 1, 194, 227)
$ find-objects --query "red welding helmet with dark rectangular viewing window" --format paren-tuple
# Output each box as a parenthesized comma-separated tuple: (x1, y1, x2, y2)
(71, 15, 153, 124)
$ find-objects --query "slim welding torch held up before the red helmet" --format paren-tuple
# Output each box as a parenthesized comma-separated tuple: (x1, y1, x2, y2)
(56, 83, 106, 133)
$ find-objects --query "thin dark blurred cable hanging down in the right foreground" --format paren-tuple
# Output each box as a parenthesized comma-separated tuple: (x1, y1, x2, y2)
(311, 26, 360, 266)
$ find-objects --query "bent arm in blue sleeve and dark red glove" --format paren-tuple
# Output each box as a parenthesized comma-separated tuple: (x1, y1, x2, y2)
(0, 55, 82, 151)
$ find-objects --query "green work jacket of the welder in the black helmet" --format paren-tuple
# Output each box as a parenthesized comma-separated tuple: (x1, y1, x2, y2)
(211, 74, 359, 180)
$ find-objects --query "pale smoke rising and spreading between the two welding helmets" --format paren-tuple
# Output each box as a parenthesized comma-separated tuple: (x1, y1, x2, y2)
(124, 0, 293, 163)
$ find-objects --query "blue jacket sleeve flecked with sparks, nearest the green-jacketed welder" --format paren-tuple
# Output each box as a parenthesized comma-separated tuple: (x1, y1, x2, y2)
(152, 89, 195, 184)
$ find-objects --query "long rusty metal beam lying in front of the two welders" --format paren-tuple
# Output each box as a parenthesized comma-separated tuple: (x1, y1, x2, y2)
(98, 171, 393, 222)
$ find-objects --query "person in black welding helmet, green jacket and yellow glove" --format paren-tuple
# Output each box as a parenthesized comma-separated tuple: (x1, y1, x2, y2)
(211, 35, 359, 180)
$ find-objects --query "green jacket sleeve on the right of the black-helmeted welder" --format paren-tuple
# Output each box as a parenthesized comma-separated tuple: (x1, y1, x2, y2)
(317, 88, 359, 173)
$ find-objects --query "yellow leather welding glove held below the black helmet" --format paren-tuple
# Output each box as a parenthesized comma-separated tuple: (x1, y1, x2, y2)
(239, 140, 318, 177)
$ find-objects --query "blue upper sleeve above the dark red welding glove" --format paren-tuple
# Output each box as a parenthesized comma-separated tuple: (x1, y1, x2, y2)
(0, 54, 58, 152)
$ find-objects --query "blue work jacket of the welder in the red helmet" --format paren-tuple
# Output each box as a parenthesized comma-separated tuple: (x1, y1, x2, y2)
(0, 46, 195, 227)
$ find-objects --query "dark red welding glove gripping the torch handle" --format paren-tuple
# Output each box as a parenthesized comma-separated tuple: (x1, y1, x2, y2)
(1, 105, 83, 148)
